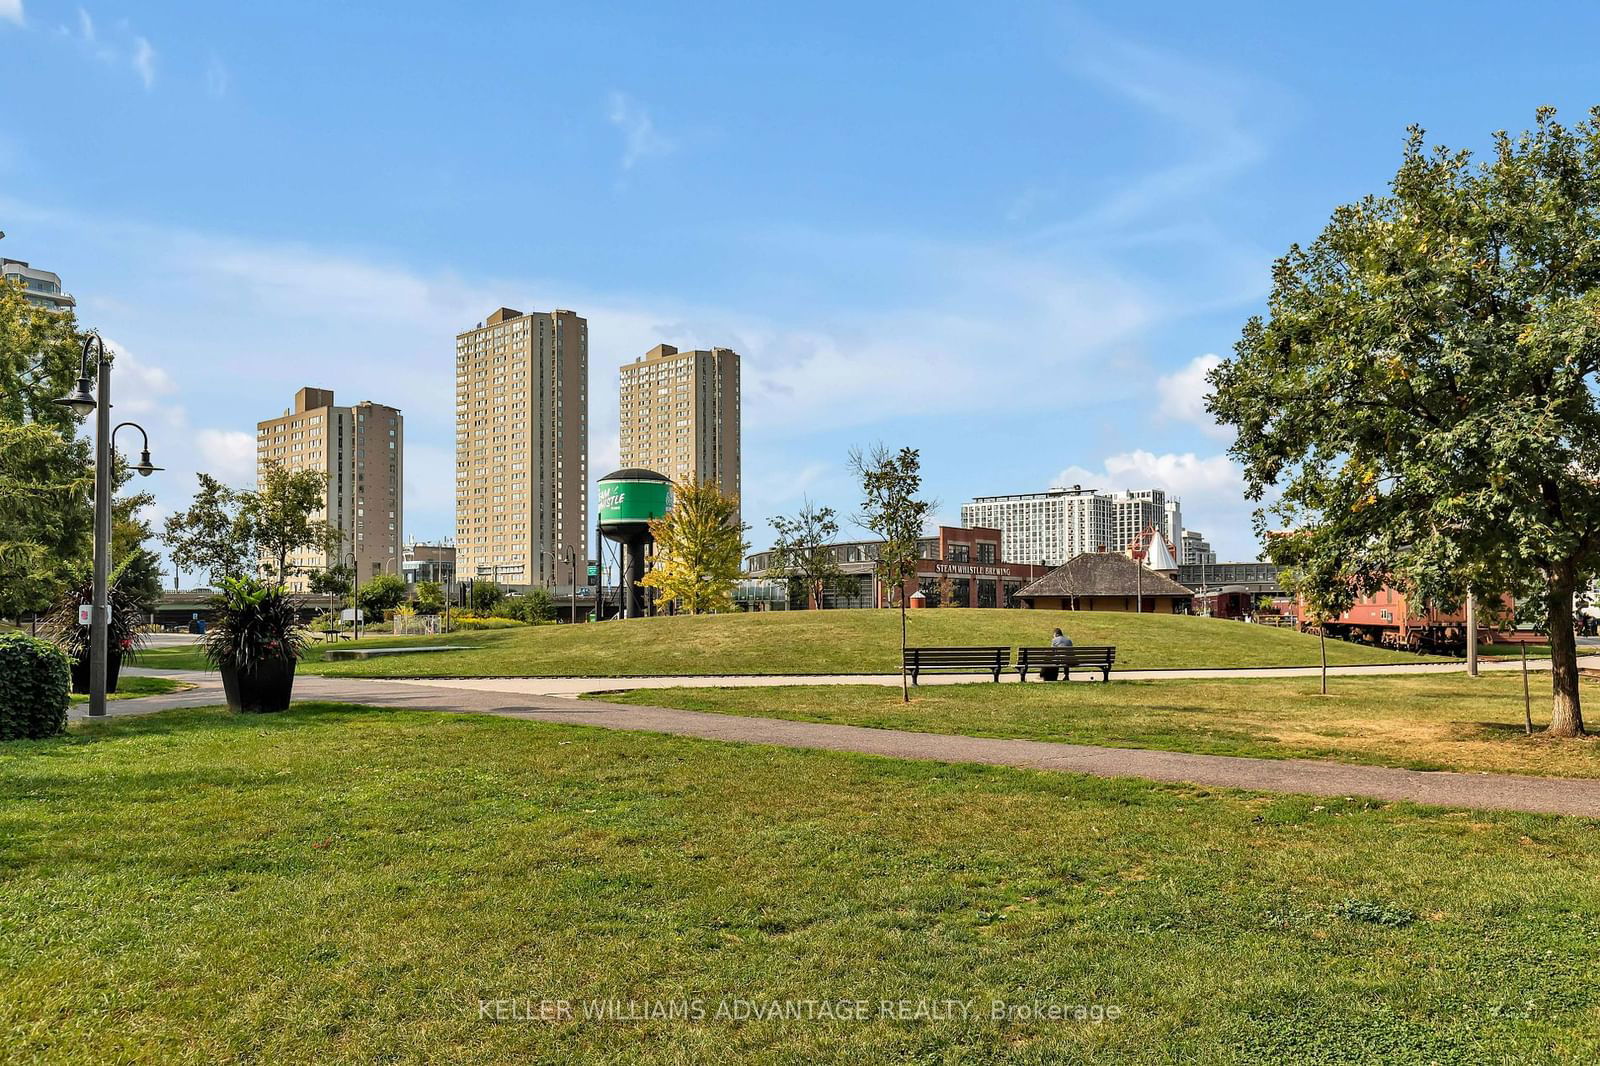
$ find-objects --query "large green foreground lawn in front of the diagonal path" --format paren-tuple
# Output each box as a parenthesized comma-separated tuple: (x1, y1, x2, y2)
(0, 706, 1600, 1063)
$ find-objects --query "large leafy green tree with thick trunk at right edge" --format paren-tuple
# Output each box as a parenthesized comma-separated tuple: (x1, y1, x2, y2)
(1208, 109, 1600, 736)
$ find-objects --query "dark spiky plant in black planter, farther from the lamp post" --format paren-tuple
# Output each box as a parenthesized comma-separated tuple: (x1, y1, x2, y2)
(202, 578, 306, 712)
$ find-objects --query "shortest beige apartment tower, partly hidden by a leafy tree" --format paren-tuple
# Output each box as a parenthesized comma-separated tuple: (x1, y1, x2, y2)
(256, 387, 405, 592)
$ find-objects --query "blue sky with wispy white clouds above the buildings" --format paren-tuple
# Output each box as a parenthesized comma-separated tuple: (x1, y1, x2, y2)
(0, 0, 1600, 573)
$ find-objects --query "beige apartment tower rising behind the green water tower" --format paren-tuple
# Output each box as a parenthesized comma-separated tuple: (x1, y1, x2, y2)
(618, 337, 739, 508)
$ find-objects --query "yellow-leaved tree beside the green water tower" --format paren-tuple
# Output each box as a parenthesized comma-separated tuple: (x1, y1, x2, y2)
(640, 480, 749, 615)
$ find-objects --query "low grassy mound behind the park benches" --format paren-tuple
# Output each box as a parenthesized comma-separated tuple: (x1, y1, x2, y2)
(291, 610, 1452, 677)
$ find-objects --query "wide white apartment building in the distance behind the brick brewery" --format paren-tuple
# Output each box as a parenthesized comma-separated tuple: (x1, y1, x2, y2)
(962, 485, 1182, 567)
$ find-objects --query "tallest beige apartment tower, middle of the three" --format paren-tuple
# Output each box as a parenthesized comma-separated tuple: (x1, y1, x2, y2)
(456, 307, 589, 587)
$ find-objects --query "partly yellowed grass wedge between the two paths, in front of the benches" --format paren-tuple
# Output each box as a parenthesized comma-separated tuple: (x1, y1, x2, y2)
(595, 674, 1600, 778)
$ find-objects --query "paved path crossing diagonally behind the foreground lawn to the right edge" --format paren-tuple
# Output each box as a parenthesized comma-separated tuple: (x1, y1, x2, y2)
(96, 671, 1600, 818)
